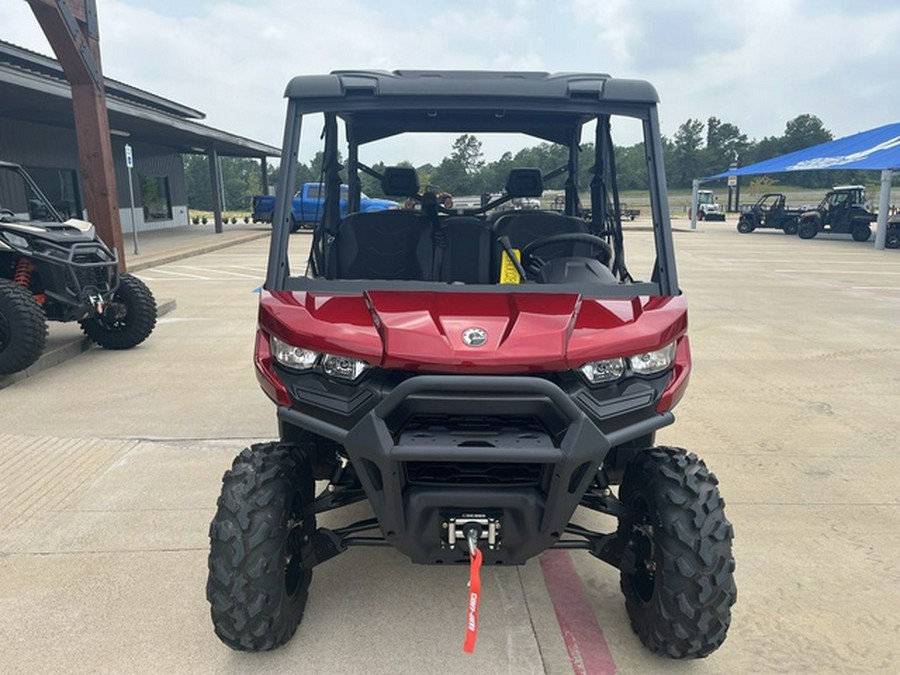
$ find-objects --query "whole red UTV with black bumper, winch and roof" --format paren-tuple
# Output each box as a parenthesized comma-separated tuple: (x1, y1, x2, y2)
(207, 71, 736, 658)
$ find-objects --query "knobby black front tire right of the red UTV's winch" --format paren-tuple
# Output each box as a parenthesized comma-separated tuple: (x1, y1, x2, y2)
(618, 447, 737, 659)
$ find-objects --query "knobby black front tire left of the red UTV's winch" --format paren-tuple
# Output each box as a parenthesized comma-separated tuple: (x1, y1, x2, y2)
(206, 443, 316, 652)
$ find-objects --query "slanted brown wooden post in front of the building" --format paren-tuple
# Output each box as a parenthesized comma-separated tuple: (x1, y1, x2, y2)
(26, 0, 125, 272)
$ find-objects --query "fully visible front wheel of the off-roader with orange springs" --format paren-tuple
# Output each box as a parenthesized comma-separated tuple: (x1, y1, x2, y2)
(80, 274, 156, 349)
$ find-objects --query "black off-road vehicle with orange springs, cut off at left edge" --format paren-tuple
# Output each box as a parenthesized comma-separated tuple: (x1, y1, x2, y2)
(0, 162, 156, 375)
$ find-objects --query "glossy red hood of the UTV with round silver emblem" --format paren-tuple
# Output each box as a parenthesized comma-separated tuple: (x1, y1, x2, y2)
(259, 291, 687, 374)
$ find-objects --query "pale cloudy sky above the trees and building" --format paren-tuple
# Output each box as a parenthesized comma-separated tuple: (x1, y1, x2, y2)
(0, 0, 900, 165)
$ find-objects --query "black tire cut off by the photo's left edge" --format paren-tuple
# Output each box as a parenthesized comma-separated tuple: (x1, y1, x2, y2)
(0, 279, 47, 375)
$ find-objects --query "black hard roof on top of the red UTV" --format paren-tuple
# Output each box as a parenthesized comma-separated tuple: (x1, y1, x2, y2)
(285, 70, 659, 145)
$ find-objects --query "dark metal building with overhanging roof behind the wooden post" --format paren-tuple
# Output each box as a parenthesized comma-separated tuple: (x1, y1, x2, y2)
(0, 40, 281, 232)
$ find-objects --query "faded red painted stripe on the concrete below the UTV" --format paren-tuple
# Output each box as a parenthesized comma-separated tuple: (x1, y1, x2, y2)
(540, 550, 616, 675)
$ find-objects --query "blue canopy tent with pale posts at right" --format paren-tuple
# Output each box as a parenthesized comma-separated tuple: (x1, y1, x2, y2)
(691, 123, 900, 249)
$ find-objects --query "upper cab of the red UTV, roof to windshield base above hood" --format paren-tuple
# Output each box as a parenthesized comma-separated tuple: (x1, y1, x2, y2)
(266, 71, 679, 297)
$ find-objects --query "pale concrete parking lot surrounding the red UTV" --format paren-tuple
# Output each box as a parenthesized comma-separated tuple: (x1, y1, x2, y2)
(0, 223, 900, 674)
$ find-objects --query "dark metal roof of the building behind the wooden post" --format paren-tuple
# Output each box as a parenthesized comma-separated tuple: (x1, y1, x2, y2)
(0, 41, 281, 157)
